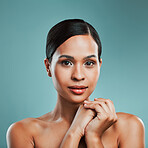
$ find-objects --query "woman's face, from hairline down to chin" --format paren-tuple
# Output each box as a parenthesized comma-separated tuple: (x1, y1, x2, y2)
(45, 35, 102, 103)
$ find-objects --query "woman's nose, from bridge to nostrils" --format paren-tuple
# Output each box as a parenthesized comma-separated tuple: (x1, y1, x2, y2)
(71, 65, 85, 81)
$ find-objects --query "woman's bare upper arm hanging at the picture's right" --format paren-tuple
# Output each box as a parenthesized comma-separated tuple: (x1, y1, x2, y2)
(119, 114, 145, 148)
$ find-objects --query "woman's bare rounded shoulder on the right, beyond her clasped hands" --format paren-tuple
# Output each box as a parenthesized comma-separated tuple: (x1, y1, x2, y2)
(116, 112, 145, 145)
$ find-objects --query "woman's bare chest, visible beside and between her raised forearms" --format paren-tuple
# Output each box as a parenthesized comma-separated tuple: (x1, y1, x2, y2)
(34, 123, 118, 148)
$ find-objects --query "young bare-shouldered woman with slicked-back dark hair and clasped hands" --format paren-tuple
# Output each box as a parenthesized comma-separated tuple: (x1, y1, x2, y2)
(7, 19, 145, 148)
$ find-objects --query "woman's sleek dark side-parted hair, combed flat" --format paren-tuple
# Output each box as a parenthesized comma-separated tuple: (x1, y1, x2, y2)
(46, 19, 102, 62)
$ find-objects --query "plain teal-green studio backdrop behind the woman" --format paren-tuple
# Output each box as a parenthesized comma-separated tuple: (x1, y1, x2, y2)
(0, 0, 148, 148)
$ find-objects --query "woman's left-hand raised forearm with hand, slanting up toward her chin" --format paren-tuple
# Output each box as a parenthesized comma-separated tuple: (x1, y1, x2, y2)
(60, 105, 95, 148)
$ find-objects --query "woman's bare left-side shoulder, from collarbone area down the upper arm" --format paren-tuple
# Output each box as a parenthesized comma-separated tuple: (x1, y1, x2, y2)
(6, 115, 53, 148)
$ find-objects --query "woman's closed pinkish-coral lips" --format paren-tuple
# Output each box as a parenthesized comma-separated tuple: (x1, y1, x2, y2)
(68, 86, 88, 95)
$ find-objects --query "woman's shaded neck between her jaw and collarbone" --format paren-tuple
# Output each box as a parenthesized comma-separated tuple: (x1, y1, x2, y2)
(52, 95, 89, 124)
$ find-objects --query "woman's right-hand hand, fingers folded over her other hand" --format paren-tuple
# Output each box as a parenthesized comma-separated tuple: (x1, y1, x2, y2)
(84, 98, 117, 138)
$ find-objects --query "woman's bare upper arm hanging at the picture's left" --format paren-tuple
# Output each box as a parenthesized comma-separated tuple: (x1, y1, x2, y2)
(6, 122, 34, 148)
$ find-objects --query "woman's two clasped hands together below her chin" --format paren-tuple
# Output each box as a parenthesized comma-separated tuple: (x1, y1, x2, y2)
(71, 98, 117, 138)
